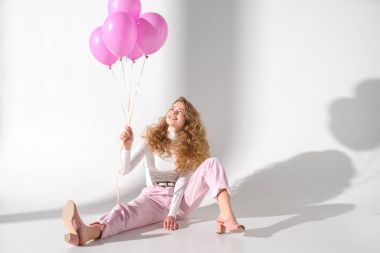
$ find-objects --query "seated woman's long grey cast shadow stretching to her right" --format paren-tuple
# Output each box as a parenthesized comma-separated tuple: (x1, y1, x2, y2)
(193, 150, 355, 237)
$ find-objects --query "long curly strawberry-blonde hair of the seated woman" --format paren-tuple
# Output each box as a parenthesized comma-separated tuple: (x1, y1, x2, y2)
(143, 97, 210, 173)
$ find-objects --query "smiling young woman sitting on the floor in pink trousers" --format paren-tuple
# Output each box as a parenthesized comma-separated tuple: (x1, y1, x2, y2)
(62, 97, 245, 245)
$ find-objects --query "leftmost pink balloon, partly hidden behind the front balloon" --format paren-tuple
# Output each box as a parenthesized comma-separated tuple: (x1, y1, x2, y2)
(90, 26, 117, 66)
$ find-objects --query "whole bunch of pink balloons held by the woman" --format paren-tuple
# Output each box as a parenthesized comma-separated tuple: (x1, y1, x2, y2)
(90, 0, 168, 67)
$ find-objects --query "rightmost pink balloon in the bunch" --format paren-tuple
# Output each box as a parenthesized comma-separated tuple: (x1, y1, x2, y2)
(136, 12, 168, 55)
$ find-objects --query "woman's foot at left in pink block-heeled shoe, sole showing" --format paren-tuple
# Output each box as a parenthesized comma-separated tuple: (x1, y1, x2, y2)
(62, 200, 100, 246)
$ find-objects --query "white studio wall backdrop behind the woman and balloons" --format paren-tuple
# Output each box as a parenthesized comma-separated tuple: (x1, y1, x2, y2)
(0, 0, 380, 220)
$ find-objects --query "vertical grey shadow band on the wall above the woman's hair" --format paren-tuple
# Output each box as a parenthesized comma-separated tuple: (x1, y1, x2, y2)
(181, 0, 238, 158)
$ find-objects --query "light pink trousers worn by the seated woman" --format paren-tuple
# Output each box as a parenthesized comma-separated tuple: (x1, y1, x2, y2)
(93, 158, 231, 238)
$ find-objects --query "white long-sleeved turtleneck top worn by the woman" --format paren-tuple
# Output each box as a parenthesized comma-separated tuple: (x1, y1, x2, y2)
(120, 132, 193, 217)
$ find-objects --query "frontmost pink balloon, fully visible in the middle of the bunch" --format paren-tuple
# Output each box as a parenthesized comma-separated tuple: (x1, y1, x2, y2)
(102, 12, 137, 58)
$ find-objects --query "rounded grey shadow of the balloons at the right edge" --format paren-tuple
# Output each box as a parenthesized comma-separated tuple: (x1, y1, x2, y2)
(330, 79, 380, 150)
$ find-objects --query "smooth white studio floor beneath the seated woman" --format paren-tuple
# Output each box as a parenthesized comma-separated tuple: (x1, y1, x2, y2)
(0, 182, 380, 253)
